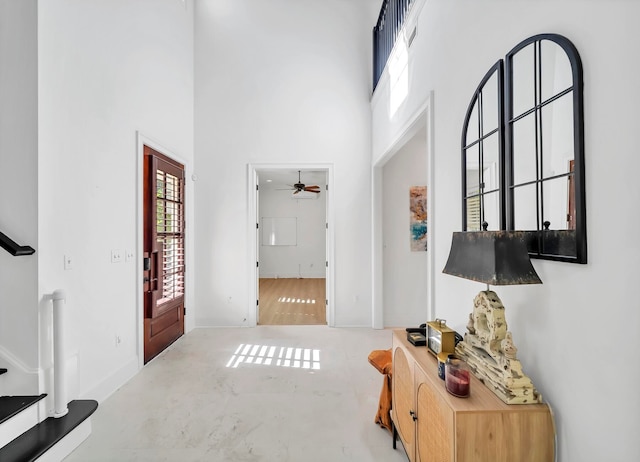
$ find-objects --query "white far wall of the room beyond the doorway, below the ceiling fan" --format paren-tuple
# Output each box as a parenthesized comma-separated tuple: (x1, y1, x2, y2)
(259, 188, 327, 278)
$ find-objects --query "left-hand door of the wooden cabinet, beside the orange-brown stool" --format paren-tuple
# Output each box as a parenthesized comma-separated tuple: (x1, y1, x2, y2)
(392, 348, 415, 461)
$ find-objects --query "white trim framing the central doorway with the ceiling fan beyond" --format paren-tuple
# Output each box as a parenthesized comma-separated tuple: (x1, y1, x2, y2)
(247, 163, 335, 327)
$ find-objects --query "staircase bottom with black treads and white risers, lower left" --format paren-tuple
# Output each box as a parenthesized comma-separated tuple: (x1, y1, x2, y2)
(0, 369, 98, 462)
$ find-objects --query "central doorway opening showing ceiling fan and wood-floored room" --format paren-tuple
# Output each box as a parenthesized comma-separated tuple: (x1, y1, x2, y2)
(250, 165, 333, 325)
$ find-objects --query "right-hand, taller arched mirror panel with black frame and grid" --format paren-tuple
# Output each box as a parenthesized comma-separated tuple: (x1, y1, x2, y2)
(505, 34, 587, 263)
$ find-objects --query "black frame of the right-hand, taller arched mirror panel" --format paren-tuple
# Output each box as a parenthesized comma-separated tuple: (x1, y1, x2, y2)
(505, 34, 587, 264)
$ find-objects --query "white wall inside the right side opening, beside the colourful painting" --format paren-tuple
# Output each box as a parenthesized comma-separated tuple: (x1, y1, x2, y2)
(382, 128, 429, 327)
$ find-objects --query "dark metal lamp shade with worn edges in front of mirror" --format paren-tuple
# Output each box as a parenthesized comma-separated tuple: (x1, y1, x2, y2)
(442, 231, 542, 286)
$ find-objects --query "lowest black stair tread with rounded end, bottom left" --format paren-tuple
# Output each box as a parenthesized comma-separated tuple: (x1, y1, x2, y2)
(0, 400, 98, 462)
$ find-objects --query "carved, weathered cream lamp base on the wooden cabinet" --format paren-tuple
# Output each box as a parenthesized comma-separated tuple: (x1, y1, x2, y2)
(456, 290, 542, 404)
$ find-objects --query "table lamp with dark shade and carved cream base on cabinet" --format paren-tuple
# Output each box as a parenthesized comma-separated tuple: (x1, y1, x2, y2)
(442, 231, 542, 404)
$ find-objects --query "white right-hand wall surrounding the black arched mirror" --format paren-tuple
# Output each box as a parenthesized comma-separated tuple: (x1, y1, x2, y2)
(373, 0, 640, 462)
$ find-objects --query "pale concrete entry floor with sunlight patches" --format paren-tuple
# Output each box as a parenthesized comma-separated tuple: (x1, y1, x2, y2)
(65, 326, 407, 462)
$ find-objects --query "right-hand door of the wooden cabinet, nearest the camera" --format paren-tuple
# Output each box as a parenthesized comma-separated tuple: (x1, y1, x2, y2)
(416, 378, 455, 462)
